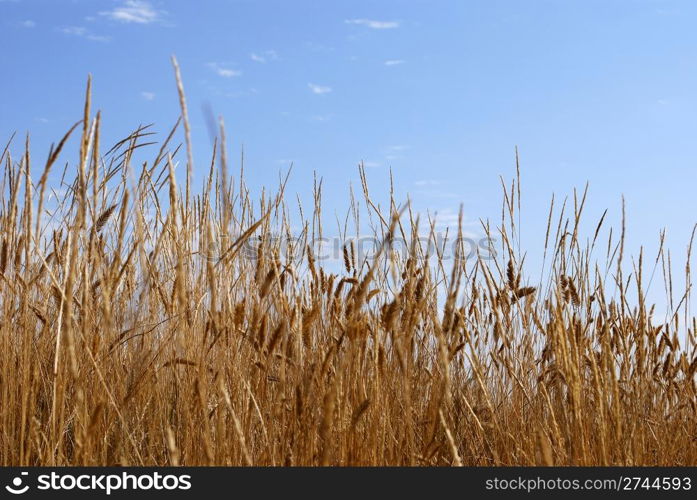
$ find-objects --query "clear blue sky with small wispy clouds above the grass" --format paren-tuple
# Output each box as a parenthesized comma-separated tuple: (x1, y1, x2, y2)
(0, 0, 697, 310)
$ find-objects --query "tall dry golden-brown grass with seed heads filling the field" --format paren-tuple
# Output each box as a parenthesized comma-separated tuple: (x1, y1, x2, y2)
(0, 64, 697, 465)
